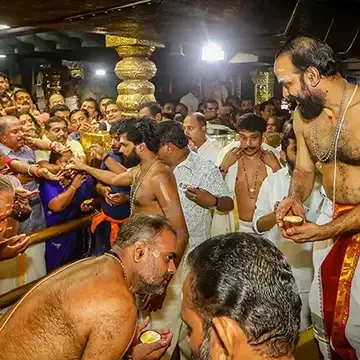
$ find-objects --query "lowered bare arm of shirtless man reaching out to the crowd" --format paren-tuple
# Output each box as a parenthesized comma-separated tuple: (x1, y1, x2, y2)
(150, 171, 189, 265)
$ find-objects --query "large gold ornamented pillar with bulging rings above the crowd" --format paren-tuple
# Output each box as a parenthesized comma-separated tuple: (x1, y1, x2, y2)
(106, 35, 165, 118)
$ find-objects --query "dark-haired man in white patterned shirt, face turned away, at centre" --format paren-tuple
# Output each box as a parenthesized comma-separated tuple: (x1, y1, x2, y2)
(155, 120, 234, 360)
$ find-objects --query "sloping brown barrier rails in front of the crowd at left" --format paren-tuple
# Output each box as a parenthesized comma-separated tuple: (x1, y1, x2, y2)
(0, 214, 94, 309)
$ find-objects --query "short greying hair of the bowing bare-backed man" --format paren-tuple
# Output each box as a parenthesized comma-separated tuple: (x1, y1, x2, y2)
(115, 215, 176, 248)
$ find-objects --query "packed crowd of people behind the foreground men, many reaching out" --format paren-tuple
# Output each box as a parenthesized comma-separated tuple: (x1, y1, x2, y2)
(0, 69, 326, 354)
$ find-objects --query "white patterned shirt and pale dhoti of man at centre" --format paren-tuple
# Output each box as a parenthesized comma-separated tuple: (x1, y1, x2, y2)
(148, 151, 233, 359)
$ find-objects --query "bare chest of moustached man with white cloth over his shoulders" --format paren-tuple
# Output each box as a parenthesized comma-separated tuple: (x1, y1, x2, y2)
(235, 151, 279, 222)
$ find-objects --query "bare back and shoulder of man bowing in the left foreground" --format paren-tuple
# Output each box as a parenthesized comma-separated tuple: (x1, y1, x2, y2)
(0, 256, 137, 360)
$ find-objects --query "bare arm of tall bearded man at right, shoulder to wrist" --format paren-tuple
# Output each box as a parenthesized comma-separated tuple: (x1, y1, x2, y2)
(289, 110, 315, 202)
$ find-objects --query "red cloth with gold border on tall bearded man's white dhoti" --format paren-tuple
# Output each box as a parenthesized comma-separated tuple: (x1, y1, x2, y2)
(320, 204, 360, 360)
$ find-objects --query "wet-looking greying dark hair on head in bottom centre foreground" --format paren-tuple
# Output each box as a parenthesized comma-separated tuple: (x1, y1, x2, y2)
(188, 233, 301, 357)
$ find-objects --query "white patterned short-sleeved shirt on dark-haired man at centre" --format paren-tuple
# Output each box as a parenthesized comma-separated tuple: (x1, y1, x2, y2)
(174, 151, 233, 251)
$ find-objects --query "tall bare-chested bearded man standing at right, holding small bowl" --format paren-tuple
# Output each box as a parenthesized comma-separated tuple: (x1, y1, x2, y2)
(275, 37, 360, 359)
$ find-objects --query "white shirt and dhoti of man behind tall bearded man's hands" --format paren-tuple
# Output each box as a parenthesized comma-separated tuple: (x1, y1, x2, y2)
(253, 167, 324, 292)
